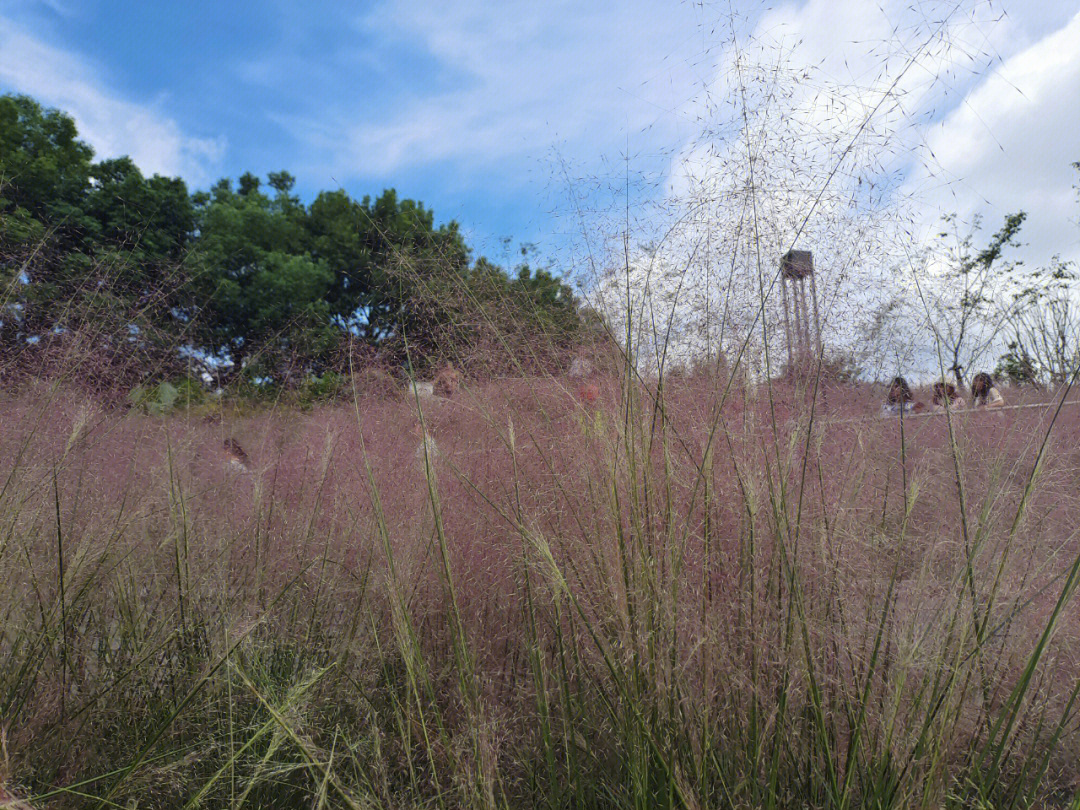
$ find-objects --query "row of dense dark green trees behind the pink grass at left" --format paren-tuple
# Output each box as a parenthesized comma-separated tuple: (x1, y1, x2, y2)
(0, 95, 579, 381)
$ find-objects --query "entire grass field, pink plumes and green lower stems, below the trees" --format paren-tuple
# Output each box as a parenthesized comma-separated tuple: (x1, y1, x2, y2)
(0, 374, 1080, 810)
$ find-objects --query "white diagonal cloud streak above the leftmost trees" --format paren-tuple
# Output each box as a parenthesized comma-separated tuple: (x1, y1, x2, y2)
(0, 17, 225, 185)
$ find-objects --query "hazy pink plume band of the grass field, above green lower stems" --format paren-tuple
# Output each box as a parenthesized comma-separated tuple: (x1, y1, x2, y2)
(0, 376, 1080, 807)
